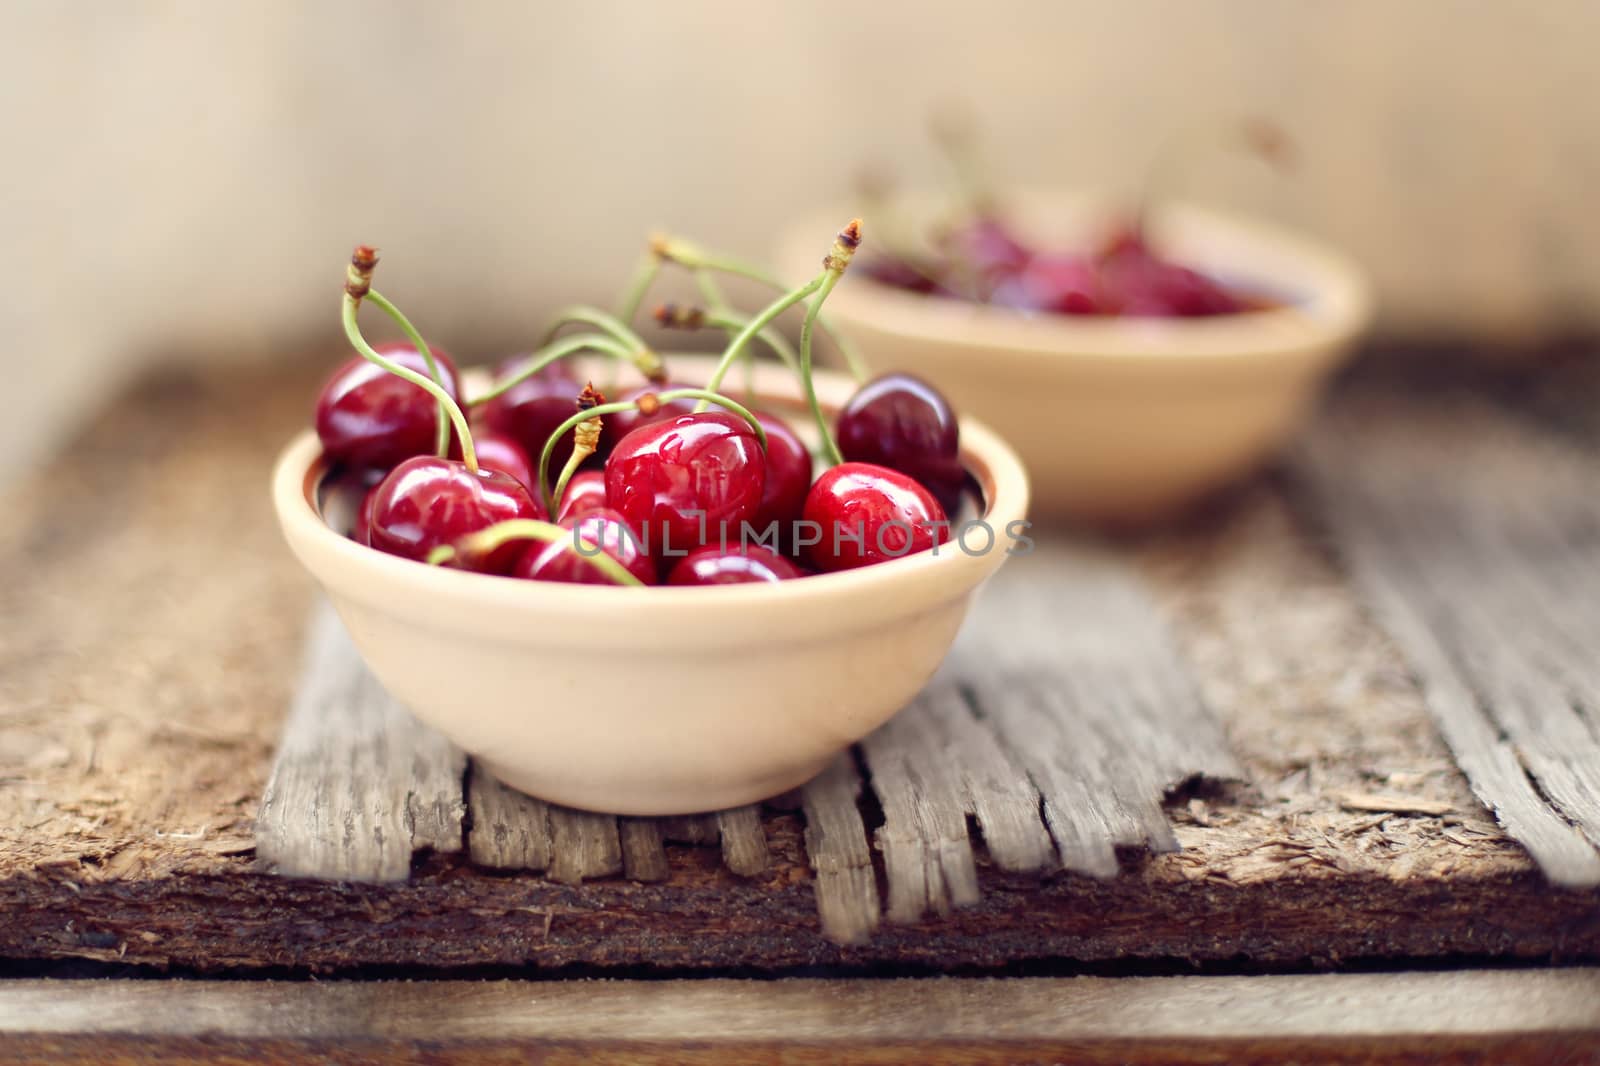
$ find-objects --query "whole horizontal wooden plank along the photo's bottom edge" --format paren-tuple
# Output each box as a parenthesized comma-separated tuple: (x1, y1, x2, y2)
(0, 970, 1600, 1064)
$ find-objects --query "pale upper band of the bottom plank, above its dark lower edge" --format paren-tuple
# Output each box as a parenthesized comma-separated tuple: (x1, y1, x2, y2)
(0, 968, 1600, 1043)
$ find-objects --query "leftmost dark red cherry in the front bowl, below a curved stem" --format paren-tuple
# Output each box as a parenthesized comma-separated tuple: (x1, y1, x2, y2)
(317, 343, 461, 467)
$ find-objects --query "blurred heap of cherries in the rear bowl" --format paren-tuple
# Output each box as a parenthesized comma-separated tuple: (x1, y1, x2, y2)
(864, 216, 1272, 319)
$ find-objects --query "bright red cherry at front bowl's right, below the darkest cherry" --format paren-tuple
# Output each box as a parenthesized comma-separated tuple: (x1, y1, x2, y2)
(803, 463, 950, 571)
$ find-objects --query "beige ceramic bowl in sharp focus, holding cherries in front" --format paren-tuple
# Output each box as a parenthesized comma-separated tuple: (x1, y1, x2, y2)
(272, 352, 1027, 815)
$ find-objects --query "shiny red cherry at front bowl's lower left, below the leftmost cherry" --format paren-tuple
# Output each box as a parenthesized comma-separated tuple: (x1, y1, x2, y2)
(370, 456, 544, 573)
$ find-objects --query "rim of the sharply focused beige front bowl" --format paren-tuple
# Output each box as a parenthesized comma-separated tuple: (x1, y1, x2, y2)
(272, 352, 1029, 623)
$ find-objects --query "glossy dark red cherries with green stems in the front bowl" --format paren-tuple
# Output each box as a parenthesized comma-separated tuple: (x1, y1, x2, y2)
(315, 221, 968, 586)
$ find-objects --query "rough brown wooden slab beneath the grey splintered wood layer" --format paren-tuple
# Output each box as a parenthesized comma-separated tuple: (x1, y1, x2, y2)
(0, 356, 1600, 972)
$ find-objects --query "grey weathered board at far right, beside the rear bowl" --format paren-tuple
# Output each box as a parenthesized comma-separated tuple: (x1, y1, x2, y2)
(1301, 385, 1600, 885)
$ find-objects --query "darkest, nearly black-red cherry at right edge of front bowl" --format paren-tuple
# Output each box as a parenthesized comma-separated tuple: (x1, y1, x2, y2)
(837, 373, 966, 512)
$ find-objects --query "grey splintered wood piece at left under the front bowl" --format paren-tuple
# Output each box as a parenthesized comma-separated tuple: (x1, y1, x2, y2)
(256, 607, 466, 880)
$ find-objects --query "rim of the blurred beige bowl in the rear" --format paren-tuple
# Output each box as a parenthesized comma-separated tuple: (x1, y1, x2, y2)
(776, 187, 1374, 370)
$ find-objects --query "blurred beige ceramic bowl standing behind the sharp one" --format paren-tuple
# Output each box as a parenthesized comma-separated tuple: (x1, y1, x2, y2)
(779, 192, 1371, 523)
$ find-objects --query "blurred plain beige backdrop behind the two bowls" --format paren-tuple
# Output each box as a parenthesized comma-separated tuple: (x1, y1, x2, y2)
(0, 0, 1600, 479)
